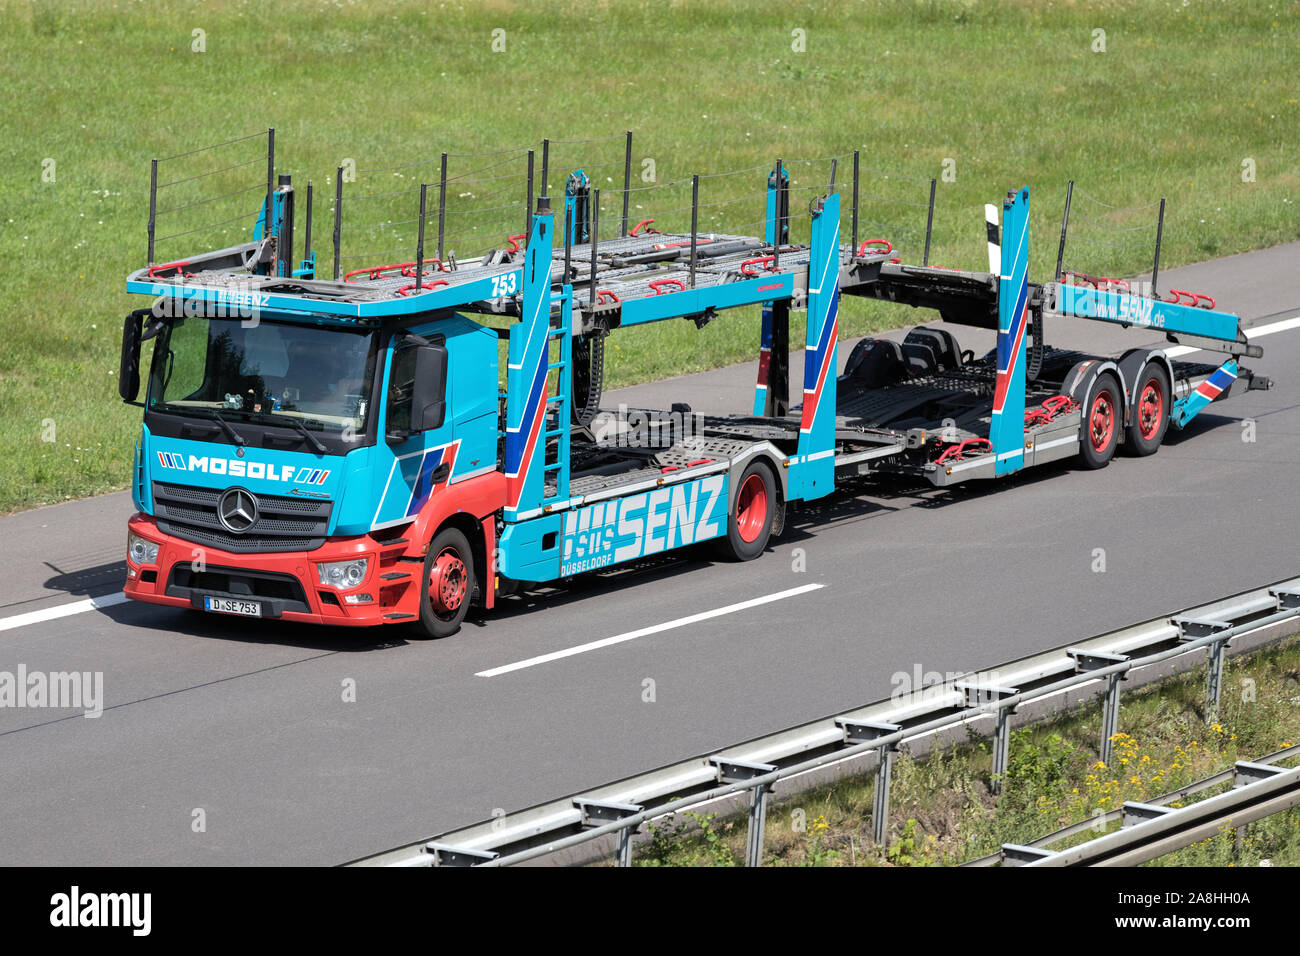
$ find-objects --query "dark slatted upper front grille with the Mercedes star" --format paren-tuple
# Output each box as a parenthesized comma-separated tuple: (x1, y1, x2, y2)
(153, 481, 333, 554)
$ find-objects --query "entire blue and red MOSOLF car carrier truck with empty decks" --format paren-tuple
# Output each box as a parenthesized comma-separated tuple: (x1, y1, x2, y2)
(120, 136, 1268, 636)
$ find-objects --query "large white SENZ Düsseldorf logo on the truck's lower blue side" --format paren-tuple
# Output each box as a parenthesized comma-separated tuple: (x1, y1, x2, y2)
(560, 475, 727, 575)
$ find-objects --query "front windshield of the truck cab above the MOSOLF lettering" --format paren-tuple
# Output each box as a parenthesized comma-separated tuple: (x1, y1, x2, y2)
(147, 316, 376, 433)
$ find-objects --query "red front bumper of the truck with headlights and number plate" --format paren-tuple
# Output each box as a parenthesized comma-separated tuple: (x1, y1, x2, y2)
(122, 514, 424, 627)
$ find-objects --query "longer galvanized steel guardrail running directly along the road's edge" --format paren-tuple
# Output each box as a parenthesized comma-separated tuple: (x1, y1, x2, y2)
(354, 578, 1300, 866)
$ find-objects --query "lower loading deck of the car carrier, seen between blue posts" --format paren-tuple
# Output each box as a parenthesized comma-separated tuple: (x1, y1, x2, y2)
(547, 335, 1251, 506)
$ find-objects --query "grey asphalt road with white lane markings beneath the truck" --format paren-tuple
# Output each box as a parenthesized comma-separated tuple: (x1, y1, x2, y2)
(0, 243, 1300, 865)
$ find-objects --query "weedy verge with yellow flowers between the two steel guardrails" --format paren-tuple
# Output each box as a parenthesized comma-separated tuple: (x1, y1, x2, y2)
(618, 637, 1300, 866)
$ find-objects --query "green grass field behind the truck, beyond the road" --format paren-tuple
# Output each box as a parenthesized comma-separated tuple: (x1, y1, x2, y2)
(0, 0, 1300, 510)
